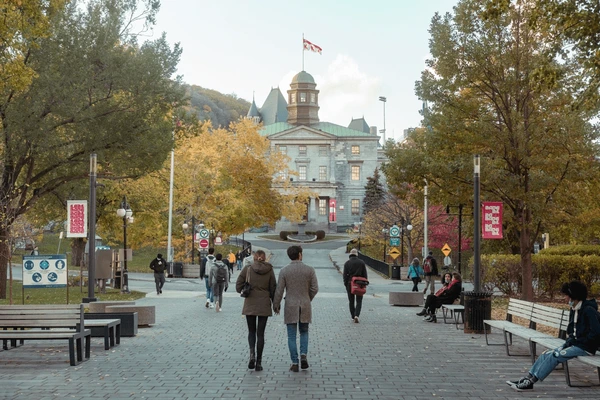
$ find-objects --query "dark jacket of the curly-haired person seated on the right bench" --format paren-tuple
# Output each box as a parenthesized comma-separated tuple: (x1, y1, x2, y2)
(566, 299, 600, 354)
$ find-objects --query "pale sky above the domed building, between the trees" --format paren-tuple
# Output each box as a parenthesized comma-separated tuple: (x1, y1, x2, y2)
(150, 0, 457, 140)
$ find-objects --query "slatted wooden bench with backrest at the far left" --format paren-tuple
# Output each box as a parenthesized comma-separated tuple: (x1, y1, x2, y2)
(0, 304, 91, 365)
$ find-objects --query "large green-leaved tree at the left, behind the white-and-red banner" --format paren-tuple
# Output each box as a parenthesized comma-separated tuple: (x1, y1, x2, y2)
(0, 0, 183, 298)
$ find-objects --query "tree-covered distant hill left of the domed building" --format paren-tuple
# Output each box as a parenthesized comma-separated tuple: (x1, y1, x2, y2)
(186, 85, 250, 128)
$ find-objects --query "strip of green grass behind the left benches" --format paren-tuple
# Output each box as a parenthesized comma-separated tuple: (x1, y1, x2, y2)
(0, 280, 146, 305)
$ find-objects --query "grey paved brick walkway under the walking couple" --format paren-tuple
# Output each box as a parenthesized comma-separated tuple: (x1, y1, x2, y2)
(0, 245, 600, 400)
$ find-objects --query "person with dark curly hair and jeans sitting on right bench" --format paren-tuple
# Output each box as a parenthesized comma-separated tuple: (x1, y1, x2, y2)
(506, 281, 600, 392)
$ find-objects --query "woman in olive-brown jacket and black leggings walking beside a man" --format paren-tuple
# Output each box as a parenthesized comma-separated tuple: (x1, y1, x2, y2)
(235, 250, 277, 371)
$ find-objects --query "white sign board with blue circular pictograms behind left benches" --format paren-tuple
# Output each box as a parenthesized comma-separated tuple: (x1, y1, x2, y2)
(23, 254, 67, 288)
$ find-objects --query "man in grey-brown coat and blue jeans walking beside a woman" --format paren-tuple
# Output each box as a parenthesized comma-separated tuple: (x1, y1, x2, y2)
(273, 246, 319, 372)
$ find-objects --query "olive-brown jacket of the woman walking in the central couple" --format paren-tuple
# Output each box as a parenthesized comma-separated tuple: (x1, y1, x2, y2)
(235, 261, 277, 317)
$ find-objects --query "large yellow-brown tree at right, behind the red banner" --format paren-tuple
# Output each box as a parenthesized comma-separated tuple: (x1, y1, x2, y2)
(384, 0, 599, 300)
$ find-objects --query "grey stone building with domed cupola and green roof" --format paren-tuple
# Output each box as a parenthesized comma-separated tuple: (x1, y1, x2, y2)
(248, 71, 383, 232)
